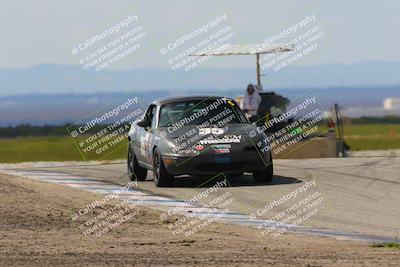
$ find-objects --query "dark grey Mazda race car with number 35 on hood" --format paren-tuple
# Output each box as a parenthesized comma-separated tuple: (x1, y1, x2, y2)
(127, 96, 273, 187)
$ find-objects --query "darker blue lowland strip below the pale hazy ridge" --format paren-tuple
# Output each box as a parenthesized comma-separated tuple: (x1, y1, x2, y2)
(0, 86, 400, 127)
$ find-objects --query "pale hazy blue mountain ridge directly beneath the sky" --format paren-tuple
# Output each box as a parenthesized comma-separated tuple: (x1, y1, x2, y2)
(0, 62, 400, 96)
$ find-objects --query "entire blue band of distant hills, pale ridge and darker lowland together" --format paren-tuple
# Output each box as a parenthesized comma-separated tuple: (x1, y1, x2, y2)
(0, 62, 400, 126)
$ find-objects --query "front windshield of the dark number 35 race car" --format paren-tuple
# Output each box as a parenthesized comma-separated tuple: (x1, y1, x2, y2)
(159, 98, 247, 127)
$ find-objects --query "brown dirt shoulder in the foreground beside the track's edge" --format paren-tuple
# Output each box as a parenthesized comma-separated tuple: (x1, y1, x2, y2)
(0, 174, 400, 266)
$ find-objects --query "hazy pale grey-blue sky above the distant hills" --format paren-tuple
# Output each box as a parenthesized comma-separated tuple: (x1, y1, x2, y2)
(0, 0, 400, 69)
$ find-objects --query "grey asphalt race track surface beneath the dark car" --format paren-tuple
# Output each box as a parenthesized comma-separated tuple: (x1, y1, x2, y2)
(0, 156, 400, 244)
